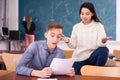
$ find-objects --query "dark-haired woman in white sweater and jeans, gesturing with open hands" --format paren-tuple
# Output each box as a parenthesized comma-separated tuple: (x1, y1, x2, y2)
(62, 2, 111, 75)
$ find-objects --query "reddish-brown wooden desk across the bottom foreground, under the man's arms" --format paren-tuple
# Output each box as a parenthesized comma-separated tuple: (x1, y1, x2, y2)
(0, 70, 120, 80)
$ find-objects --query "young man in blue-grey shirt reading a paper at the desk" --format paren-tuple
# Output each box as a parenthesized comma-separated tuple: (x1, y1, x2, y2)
(16, 22, 75, 78)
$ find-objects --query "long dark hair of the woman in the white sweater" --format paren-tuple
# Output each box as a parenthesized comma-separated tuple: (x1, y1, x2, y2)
(79, 2, 101, 22)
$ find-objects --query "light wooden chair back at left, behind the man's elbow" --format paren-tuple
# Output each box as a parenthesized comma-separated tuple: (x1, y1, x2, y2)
(2, 52, 23, 71)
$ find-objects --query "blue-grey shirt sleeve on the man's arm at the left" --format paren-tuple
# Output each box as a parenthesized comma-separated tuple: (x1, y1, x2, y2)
(16, 43, 35, 76)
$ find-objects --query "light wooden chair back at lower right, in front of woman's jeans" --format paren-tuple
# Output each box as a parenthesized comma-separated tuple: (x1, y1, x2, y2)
(81, 65, 120, 77)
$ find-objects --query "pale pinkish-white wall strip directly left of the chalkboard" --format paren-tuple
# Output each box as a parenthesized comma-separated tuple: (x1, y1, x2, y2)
(6, 0, 18, 30)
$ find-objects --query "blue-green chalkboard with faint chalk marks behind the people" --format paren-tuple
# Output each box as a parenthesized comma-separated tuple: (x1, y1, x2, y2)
(19, 0, 116, 40)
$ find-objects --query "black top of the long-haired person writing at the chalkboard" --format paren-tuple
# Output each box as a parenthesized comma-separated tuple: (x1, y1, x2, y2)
(22, 21, 35, 34)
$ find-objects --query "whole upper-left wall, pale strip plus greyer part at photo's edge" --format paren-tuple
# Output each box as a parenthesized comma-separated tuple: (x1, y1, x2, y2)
(0, 0, 19, 39)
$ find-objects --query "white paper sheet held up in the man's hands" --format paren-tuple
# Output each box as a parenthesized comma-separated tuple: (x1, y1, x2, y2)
(50, 58, 75, 75)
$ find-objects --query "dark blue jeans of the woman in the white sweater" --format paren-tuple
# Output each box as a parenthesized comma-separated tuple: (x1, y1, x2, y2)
(73, 47, 109, 75)
